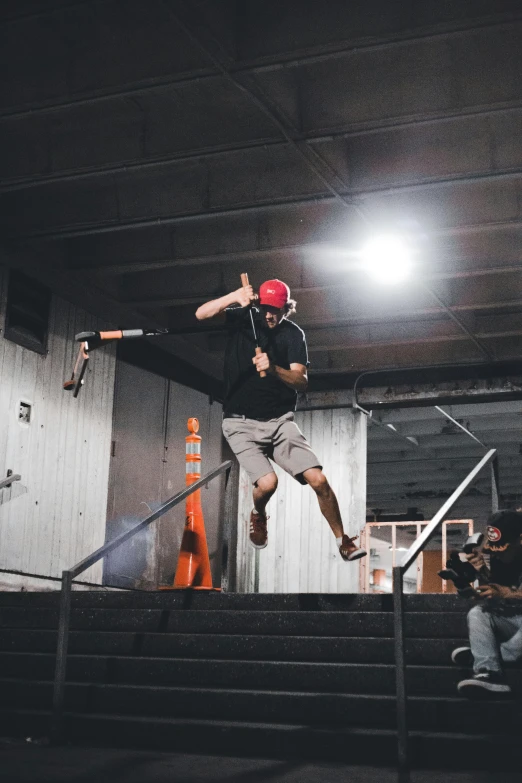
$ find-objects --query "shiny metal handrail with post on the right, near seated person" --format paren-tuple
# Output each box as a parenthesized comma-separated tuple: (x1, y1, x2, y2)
(393, 449, 498, 769)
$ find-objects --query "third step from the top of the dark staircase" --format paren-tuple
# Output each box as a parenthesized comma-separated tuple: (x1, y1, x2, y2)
(0, 628, 465, 664)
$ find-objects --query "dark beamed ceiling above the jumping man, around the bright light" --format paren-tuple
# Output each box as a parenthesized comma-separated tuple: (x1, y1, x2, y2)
(0, 0, 522, 390)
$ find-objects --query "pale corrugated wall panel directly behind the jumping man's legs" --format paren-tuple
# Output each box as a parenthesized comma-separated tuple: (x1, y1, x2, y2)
(237, 409, 367, 593)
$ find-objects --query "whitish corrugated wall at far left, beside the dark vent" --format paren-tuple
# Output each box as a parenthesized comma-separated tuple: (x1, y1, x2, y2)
(0, 268, 115, 584)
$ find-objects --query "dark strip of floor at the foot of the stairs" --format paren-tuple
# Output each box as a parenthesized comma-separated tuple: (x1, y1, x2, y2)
(0, 740, 520, 783)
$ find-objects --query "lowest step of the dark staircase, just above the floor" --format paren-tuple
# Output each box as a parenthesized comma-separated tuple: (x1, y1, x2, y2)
(0, 709, 520, 772)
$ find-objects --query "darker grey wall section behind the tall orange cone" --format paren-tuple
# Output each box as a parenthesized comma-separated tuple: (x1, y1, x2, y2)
(105, 358, 223, 588)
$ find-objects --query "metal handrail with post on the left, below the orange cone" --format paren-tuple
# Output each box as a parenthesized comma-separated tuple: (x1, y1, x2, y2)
(51, 460, 234, 743)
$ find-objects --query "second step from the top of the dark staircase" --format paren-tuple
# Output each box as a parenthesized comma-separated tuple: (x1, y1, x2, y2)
(0, 607, 467, 638)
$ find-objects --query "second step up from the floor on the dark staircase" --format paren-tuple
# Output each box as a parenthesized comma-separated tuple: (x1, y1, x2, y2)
(0, 679, 521, 735)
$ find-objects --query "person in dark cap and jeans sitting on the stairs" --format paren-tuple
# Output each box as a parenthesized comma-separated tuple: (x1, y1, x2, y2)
(451, 511, 522, 697)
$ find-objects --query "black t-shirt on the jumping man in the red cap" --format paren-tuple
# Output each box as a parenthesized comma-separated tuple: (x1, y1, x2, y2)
(223, 307, 308, 419)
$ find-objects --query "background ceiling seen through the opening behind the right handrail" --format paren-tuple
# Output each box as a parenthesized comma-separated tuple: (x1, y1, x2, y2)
(368, 401, 522, 520)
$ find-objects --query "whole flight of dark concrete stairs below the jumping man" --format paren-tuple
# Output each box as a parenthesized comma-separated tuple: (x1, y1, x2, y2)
(0, 592, 522, 768)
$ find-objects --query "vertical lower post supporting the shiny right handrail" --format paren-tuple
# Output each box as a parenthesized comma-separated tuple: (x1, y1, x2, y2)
(393, 565, 409, 770)
